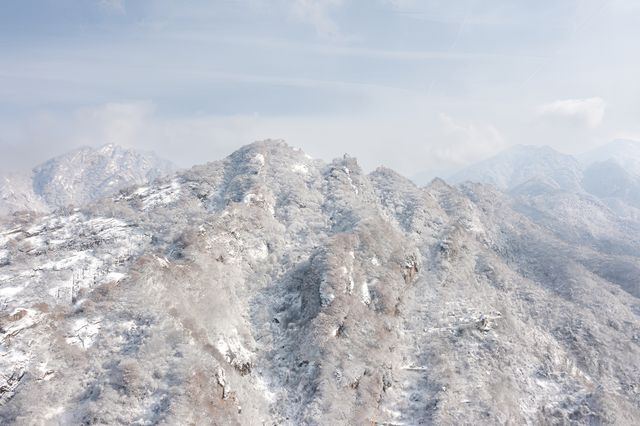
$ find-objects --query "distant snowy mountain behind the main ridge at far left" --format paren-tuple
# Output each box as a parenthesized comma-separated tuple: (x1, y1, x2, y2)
(0, 144, 175, 215)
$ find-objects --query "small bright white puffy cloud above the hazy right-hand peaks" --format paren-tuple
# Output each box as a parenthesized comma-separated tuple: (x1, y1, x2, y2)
(540, 97, 606, 128)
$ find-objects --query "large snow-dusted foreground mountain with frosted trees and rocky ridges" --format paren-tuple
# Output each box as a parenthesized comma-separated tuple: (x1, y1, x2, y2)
(0, 141, 640, 425)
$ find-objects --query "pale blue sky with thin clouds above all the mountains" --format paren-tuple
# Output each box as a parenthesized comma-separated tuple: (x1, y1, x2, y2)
(0, 0, 640, 176)
